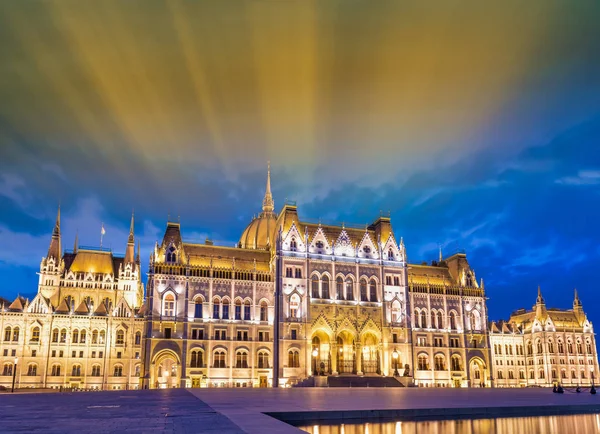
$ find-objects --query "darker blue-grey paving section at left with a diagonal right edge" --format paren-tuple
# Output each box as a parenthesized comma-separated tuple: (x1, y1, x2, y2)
(0, 389, 243, 434)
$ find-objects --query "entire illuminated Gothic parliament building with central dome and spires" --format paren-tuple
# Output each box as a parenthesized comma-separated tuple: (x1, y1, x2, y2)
(0, 167, 598, 390)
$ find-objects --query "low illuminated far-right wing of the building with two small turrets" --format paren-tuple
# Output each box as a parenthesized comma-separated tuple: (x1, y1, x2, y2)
(490, 288, 598, 387)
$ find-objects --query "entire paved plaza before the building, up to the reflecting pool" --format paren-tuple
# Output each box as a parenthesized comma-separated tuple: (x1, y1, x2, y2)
(0, 388, 600, 434)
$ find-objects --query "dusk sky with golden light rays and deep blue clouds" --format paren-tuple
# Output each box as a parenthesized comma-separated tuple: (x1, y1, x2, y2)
(0, 0, 600, 321)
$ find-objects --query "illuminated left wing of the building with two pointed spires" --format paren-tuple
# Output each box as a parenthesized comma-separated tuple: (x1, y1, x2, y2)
(0, 211, 144, 390)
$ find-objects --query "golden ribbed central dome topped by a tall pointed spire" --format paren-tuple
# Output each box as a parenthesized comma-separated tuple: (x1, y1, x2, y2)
(239, 165, 277, 249)
